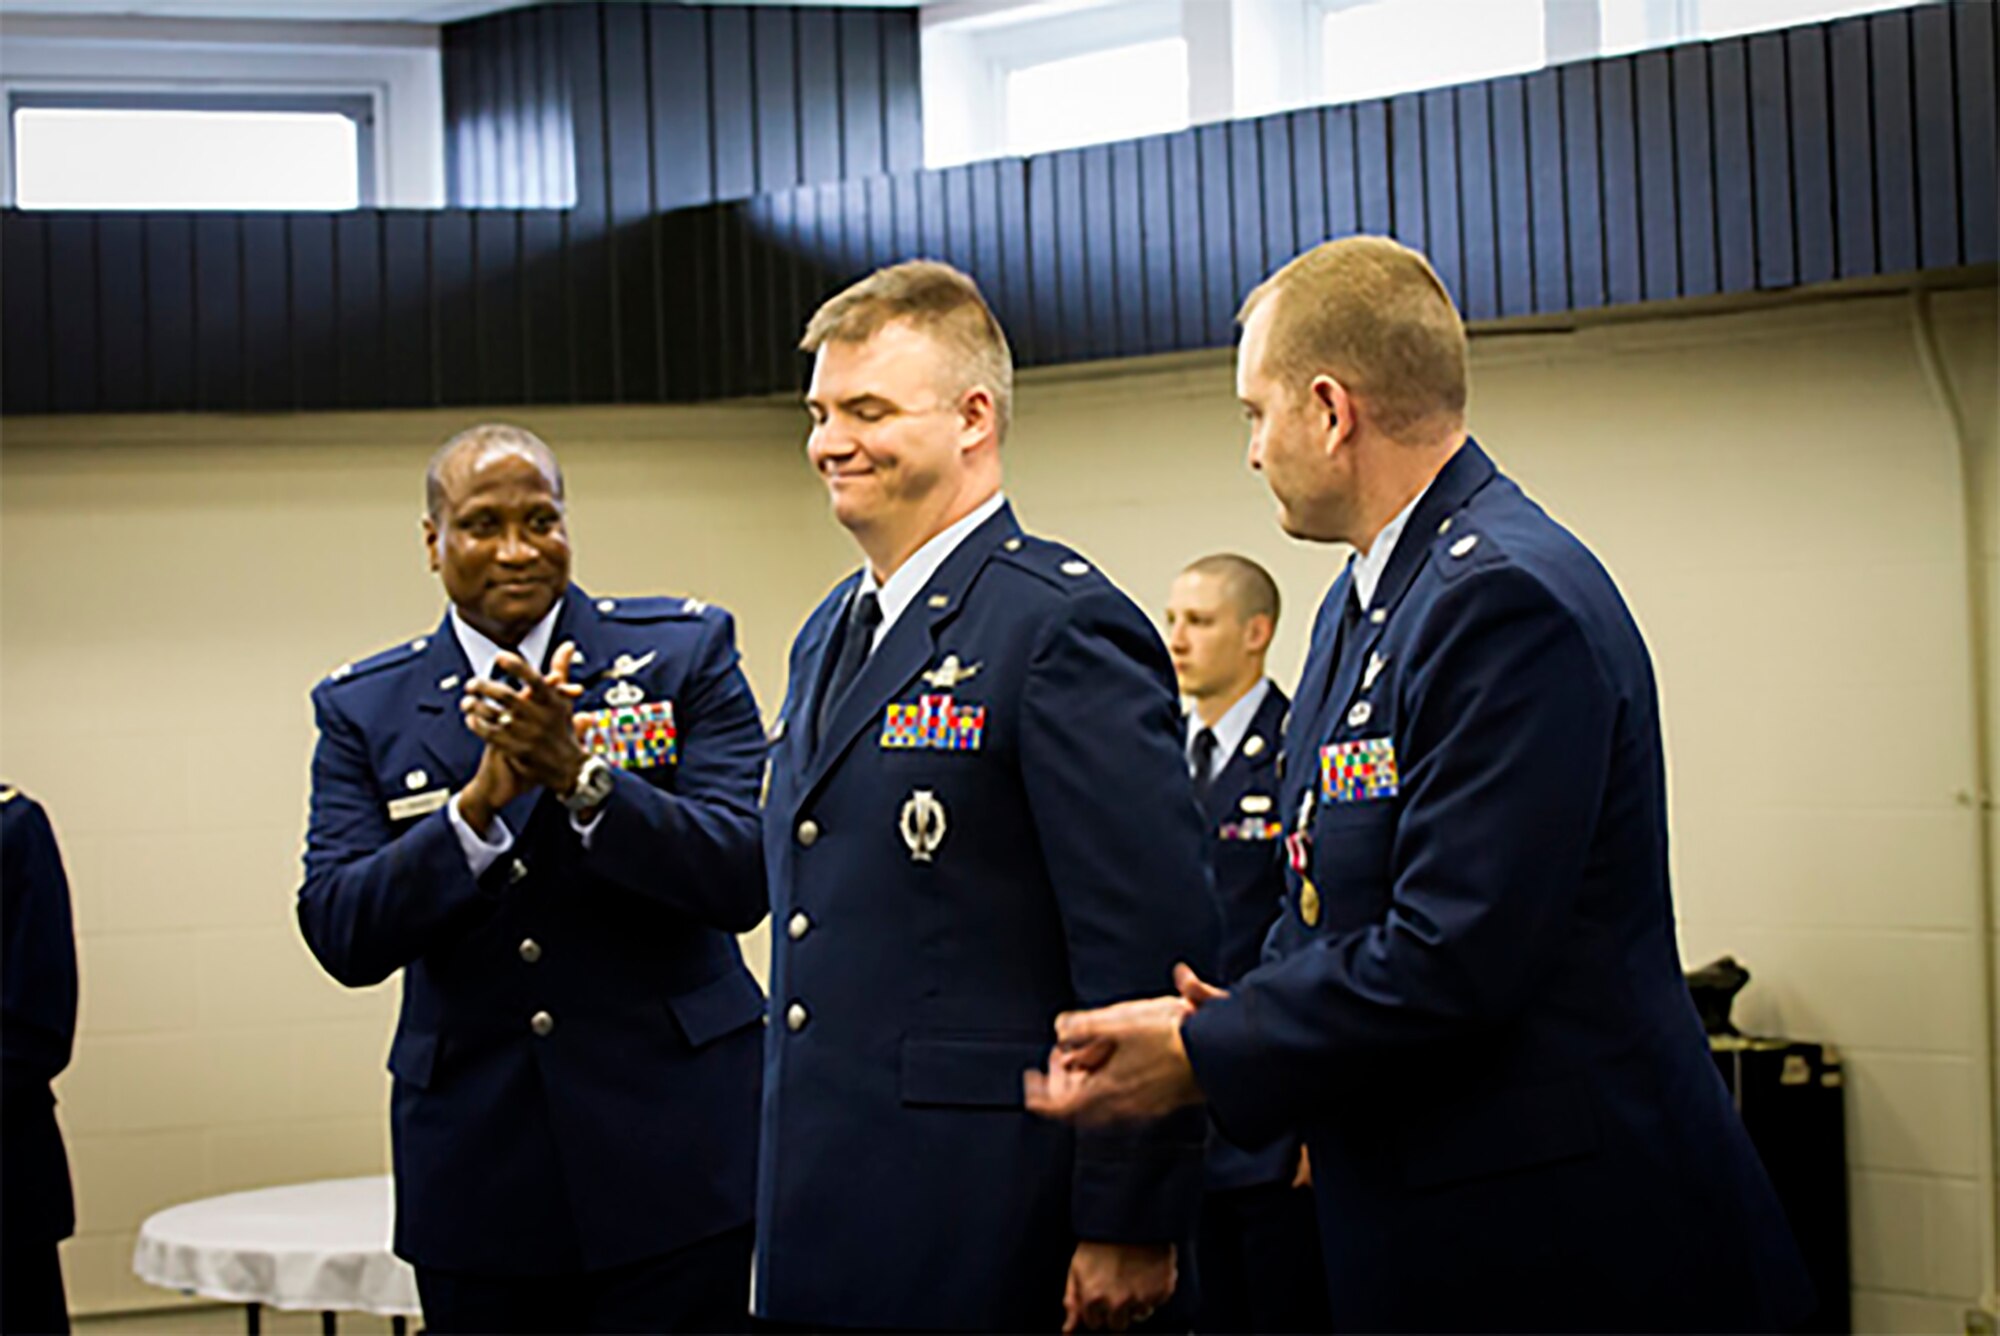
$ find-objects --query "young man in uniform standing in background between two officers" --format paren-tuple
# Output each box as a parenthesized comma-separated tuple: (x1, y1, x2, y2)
(1166, 552, 1332, 1332)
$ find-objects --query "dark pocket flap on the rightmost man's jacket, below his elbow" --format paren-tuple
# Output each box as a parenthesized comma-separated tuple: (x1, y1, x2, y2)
(1404, 1080, 1598, 1188)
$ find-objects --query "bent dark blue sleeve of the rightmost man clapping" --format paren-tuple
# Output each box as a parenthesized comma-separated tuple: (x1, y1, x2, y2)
(1182, 566, 1620, 1140)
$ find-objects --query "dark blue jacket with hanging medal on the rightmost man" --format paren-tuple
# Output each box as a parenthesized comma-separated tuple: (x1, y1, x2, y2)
(1184, 442, 1806, 1330)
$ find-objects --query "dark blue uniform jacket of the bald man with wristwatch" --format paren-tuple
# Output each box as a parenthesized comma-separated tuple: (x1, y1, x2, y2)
(298, 586, 766, 1274)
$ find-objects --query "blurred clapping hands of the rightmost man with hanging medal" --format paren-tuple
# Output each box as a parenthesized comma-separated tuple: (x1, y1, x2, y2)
(1022, 964, 1228, 1126)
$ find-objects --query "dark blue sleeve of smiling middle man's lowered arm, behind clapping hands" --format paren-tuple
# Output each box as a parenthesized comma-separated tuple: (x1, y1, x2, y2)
(1020, 586, 1222, 1242)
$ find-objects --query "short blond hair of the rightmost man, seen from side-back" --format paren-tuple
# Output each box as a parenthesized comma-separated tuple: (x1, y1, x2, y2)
(1236, 236, 1466, 438)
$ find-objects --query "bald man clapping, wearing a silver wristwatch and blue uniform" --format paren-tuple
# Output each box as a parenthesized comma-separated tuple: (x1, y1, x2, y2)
(298, 426, 766, 1332)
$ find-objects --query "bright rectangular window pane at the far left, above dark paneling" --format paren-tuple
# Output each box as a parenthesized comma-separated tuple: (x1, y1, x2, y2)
(14, 106, 360, 208)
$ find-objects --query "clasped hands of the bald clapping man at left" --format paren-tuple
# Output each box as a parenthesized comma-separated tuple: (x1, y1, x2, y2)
(458, 642, 584, 830)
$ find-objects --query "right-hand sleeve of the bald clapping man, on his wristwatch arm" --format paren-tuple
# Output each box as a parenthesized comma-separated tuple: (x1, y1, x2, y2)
(586, 610, 770, 932)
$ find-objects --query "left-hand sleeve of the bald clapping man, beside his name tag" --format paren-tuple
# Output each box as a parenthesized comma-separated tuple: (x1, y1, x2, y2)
(298, 686, 504, 988)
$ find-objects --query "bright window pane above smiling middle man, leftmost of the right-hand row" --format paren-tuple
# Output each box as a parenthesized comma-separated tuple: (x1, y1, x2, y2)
(1006, 38, 1188, 154)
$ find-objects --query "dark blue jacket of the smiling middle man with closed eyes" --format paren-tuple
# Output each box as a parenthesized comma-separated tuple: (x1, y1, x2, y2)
(754, 508, 1216, 1330)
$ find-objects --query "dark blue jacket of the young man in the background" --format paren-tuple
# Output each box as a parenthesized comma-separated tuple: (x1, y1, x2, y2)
(1202, 682, 1298, 1190)
